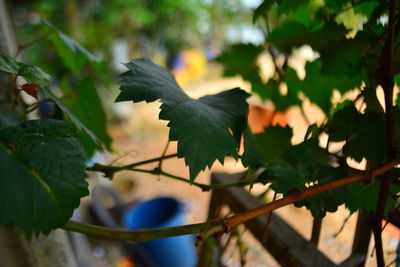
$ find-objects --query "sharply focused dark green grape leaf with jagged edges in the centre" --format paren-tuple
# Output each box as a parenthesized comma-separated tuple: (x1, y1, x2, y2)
(116, 59, 248, 180)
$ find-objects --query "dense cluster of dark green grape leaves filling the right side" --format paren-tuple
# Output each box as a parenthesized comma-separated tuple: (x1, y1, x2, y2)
(218, 0, 400, 220)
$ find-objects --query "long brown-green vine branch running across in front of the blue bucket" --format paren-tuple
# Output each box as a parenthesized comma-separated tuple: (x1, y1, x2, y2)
(62, 159, 400, 242)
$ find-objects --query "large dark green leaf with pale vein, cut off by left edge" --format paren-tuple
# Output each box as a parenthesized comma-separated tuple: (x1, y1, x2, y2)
(0, 120, 88, 237)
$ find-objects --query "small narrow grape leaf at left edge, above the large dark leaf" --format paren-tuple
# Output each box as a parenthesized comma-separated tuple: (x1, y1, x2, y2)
(0, 54, 51, 86)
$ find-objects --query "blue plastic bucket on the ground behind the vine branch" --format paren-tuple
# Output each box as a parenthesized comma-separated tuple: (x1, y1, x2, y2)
(123, 197, 197, 267)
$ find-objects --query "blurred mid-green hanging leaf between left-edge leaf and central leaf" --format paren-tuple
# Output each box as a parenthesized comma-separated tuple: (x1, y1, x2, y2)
(61, 79, 111, 155)
